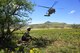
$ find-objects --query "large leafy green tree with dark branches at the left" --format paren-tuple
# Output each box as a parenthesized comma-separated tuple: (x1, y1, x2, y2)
(0, 0, 34, 48)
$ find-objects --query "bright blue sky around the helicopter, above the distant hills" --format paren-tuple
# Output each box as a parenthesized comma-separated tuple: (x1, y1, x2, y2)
(30, 0, 80, 24)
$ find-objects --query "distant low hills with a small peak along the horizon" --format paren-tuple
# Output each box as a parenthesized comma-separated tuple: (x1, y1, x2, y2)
(30, 21, 80, 28)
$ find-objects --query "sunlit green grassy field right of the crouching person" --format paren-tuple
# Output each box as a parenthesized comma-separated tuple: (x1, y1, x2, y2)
(13, 29, 80, 53)
